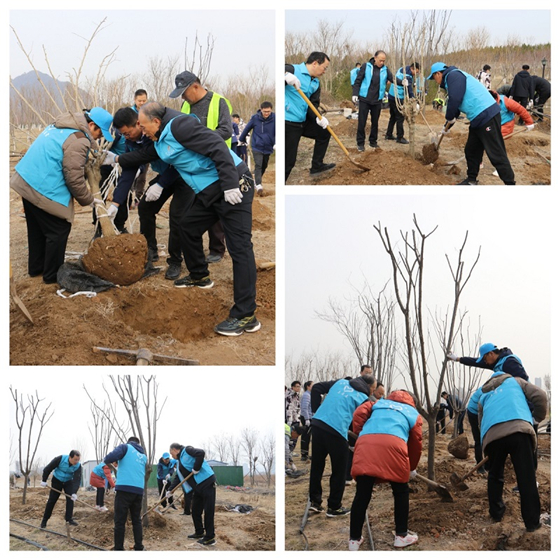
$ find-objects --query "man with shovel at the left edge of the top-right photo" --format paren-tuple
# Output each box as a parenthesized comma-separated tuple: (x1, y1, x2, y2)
(284, 51, 336, 181)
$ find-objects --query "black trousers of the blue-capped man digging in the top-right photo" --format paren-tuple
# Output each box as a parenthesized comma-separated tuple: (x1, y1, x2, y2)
(465, 114, 515, 185)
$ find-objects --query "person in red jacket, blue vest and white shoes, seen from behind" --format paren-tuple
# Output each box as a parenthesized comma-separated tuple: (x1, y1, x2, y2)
(348, 390, 422, 550)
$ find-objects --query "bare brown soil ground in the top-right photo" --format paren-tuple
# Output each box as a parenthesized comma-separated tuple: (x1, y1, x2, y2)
(287, 108, 551, 185)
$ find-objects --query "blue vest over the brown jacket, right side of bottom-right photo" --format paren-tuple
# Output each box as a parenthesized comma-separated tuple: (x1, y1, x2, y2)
(480, 373, 533, 442)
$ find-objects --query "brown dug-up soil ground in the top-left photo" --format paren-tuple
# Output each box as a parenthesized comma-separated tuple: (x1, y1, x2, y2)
(10, 158, 275, 365)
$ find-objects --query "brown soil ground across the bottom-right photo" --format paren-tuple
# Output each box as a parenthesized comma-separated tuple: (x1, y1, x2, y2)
(286, 424, 551, 551)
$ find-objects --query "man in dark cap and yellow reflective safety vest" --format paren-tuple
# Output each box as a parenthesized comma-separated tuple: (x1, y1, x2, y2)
(169, 71, 233, 263)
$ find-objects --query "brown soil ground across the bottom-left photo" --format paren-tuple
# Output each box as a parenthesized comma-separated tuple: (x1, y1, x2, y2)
(10, 486, 275, 551)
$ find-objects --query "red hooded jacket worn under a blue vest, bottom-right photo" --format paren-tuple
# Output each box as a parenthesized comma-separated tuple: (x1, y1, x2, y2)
(352, 391, 422, 482)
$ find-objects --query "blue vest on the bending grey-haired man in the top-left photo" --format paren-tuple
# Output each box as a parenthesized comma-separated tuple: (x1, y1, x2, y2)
(154, 114, 241, 194)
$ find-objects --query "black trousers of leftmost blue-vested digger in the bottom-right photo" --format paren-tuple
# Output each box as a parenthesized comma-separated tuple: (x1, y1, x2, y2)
(309, 426, 348, 509)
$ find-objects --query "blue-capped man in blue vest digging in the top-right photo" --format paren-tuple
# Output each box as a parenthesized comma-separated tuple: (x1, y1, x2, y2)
(427, 62, 515, 185)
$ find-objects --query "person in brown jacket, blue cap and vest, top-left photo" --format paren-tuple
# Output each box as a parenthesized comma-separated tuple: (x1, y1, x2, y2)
(10, 107, 113, 284)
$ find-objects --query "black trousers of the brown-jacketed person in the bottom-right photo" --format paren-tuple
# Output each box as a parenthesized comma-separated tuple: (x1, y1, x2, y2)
(486, 432, 541, 529)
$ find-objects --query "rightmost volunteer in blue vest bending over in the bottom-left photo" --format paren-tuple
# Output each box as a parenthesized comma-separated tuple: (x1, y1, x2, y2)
(167, 443, 216, 546)
